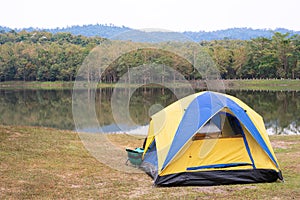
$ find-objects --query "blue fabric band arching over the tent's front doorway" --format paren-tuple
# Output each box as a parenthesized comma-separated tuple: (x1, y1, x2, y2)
(162, 92, 278, 170)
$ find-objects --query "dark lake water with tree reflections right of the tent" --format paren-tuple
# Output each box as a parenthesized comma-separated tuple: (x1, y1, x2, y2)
(227, 91, 300, 134)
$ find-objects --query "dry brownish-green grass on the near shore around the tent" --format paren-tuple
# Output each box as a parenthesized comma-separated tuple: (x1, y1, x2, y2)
(0, 126, 300, 199)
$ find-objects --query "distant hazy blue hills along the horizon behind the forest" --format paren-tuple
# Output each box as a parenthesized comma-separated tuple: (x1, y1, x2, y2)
(0, 24, 300, 42)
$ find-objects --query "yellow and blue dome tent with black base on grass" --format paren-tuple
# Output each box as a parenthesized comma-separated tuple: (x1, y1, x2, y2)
(141, 91, 283, 186)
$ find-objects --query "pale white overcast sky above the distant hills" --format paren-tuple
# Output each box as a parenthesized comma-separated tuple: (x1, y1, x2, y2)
(0, 0, 300, 31)
